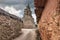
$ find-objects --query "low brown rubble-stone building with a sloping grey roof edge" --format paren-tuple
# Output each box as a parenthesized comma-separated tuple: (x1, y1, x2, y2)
(0, 9, 23, 40)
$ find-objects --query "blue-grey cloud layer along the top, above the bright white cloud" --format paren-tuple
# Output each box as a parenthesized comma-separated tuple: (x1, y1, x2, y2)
(0, 0, 34, 9)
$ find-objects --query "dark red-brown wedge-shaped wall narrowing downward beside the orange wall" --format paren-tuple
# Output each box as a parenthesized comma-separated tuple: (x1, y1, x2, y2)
(34, 0, 47, 23)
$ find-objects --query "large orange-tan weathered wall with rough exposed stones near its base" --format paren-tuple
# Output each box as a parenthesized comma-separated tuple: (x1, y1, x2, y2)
(39, 0, 60, 40)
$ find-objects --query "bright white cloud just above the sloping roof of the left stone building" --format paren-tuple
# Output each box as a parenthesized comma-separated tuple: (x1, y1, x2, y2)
(0, 6, 22, 17)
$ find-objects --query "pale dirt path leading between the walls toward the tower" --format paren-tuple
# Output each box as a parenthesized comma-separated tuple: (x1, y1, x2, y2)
(14, 29, 36, 40)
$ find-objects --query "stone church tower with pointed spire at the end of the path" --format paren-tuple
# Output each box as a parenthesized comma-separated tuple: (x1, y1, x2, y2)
(22, 4, 35, 28)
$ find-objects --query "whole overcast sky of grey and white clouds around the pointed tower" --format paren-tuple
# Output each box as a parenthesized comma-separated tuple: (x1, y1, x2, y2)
(0, 0, 36, 21)
